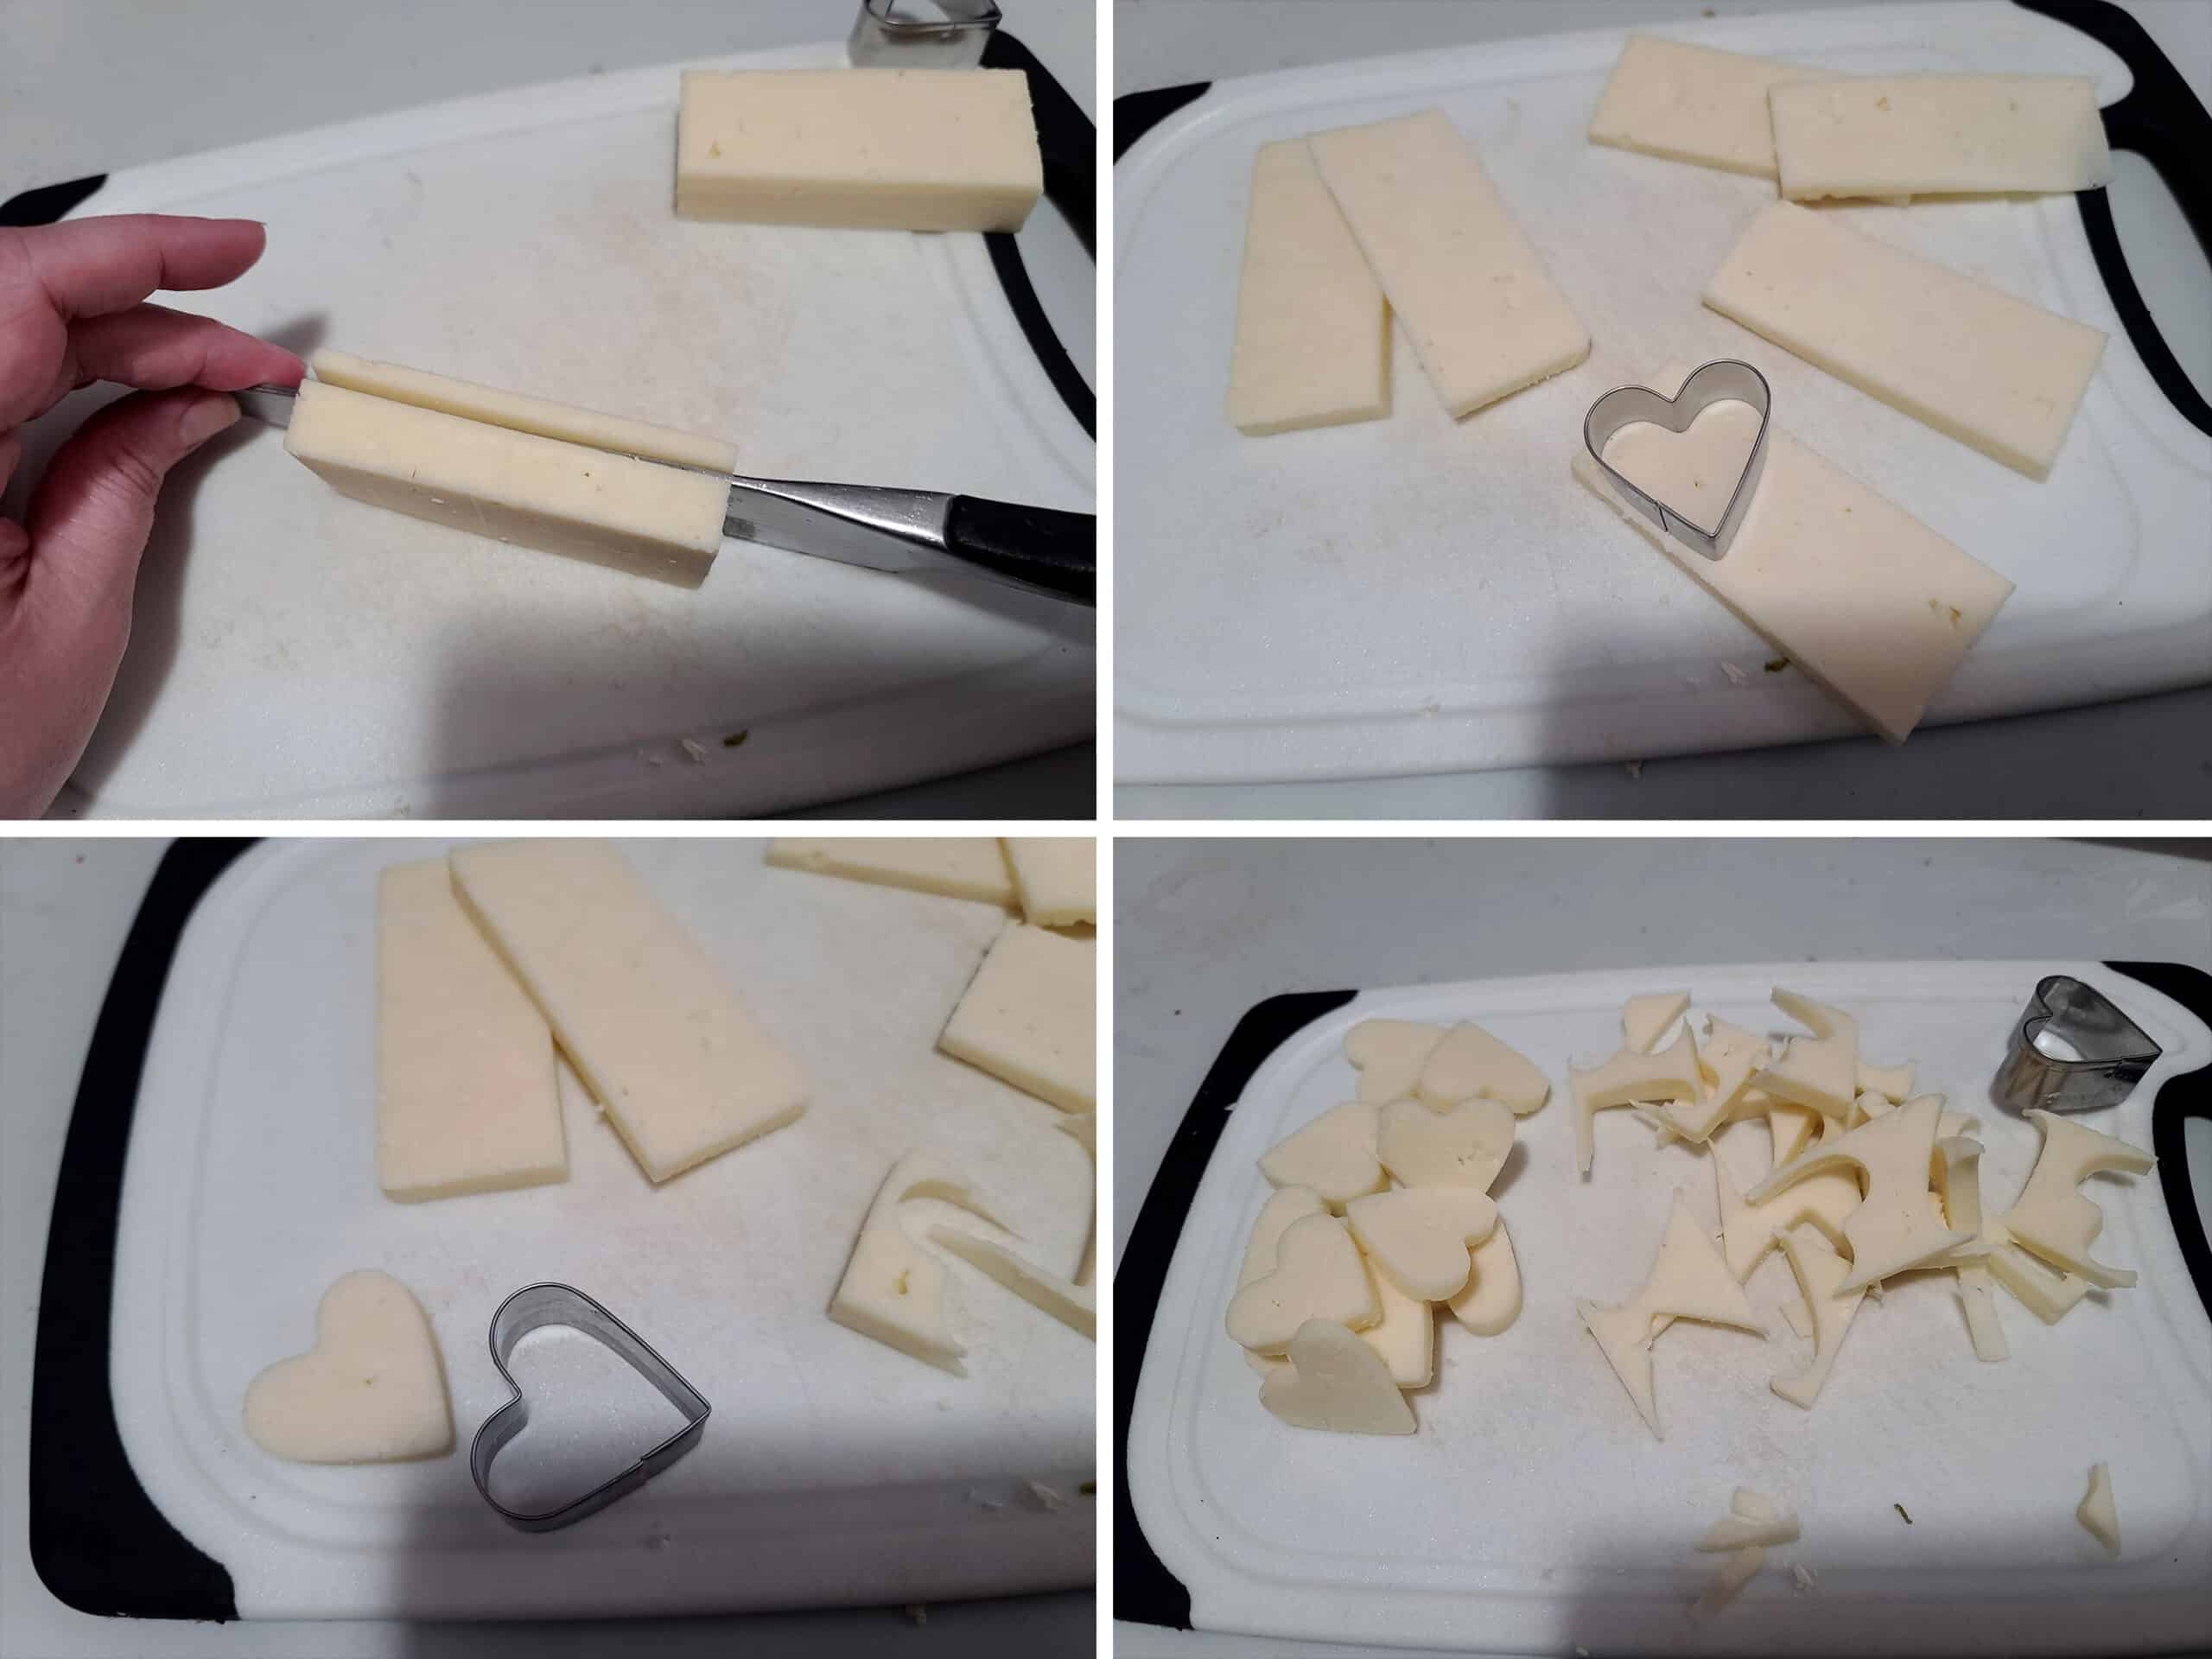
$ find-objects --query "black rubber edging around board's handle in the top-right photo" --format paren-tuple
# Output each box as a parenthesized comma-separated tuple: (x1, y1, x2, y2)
(2015, 0, 2212, 435)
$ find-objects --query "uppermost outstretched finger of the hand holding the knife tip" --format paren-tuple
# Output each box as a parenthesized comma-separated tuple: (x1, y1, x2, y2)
(13, 213, 268, 321)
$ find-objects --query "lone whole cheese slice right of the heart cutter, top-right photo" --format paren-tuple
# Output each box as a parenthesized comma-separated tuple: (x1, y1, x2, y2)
(1706, 201, 2104, 478)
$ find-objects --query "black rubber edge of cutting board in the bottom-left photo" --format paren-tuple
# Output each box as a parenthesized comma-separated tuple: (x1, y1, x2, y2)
(29, 836, 252, 1619)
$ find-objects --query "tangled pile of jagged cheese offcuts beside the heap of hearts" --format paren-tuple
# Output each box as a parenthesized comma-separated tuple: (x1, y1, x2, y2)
(1568, 988, 2154, 1435)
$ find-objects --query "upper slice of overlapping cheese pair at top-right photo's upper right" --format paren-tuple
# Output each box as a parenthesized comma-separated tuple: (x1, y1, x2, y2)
(1767, 75, 2113, 201)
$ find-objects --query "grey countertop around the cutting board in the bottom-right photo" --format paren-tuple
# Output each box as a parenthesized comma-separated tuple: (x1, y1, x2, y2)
(1113, 836, 2212, 1659)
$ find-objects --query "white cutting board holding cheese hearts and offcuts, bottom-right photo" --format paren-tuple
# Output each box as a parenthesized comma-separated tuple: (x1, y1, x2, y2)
(1128, 963, 2212, 1655)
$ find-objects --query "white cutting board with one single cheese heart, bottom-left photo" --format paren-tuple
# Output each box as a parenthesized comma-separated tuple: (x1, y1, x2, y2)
(111, 841, 1095, 1617)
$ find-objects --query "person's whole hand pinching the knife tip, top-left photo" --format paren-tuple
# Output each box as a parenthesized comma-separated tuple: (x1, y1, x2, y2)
(0, 214, 305, 818)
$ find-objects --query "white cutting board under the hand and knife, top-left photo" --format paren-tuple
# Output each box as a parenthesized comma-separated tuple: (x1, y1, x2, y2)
(11, 47, 1095, 818)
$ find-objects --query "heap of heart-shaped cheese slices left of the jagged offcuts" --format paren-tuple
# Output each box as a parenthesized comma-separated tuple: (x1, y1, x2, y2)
(1228, 1020, 1551, 1433)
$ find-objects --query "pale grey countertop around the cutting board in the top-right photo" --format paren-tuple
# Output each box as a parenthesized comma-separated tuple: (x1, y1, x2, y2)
(1113, 0, 2212, 818)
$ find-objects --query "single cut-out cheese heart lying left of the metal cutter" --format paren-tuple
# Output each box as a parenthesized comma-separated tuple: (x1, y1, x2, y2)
(245, 1269, 454, 1462)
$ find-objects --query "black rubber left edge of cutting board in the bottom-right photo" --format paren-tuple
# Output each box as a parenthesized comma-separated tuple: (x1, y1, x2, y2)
(1113, 991, 1356, 1630)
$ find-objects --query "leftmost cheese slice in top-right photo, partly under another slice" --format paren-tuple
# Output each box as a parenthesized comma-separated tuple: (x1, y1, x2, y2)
(1230, 139, 1389, 438)
